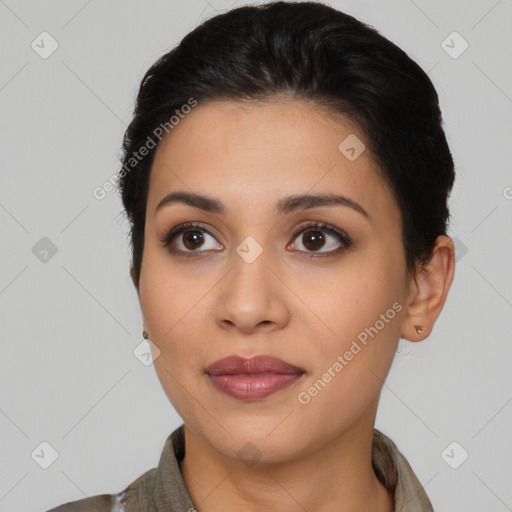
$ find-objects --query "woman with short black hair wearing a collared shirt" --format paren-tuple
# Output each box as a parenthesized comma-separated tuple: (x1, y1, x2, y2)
(49, 2, 454, 512)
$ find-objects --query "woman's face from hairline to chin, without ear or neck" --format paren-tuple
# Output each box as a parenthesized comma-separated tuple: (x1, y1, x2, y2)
(139, 100, 410, 462)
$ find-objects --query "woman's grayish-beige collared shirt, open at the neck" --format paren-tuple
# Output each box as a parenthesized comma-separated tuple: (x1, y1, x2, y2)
(48, 425, 433, 512)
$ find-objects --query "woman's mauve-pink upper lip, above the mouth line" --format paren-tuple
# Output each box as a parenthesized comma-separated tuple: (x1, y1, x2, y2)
(206, 355, 305, 375)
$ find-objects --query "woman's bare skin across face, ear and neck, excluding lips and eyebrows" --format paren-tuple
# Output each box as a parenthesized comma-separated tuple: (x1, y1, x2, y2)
(135, 98, 454, 512)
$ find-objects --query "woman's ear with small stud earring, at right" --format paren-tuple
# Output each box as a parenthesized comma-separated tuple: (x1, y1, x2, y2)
(401, 235, 455, 341)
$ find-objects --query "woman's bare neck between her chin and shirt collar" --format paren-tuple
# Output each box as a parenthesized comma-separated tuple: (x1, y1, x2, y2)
(181, 412, 394, 512)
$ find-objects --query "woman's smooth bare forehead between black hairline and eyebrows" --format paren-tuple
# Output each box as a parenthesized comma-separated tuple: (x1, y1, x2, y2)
(148, 100, 396, 221)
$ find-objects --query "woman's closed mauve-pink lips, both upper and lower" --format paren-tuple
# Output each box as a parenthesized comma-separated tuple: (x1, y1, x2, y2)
(206, 356, 305, 401)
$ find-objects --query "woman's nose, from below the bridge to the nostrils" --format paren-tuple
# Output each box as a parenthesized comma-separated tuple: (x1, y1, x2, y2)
(216, 250, 291, 334)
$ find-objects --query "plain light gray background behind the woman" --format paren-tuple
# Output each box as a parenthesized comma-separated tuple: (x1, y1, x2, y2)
(0, 0, 512, 512)
